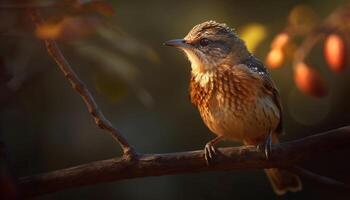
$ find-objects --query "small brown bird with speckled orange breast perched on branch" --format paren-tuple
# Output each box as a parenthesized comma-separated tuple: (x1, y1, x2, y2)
(164, 20, 302, 195)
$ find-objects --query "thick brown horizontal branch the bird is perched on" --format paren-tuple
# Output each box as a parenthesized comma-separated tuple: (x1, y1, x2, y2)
(20, 126, 350, 196)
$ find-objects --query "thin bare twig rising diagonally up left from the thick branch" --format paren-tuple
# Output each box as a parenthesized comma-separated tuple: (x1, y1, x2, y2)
(30, 11, 137, 159)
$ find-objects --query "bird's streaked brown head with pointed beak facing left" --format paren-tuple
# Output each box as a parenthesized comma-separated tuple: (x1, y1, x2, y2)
(165, 21, 250, 72)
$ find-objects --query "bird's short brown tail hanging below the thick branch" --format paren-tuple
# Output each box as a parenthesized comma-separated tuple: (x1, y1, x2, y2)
(265, 137, 303, 195)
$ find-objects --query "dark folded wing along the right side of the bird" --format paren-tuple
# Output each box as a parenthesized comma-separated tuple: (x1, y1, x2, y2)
(242, 56, 283, 133)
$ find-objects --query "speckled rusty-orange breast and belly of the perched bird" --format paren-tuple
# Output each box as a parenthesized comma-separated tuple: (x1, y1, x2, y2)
(190, 67, 280, 144)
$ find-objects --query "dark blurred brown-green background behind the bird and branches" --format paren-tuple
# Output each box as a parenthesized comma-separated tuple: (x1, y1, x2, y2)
(0, 0, 350, 200)
